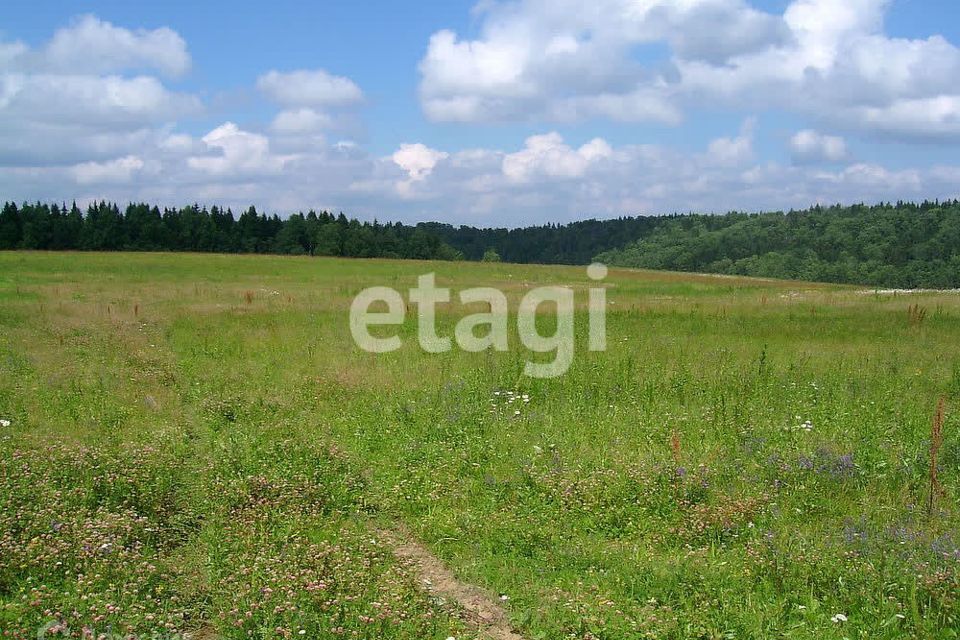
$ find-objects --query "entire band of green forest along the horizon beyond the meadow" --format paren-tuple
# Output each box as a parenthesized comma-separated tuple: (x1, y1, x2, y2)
(0, 200, 960, 288)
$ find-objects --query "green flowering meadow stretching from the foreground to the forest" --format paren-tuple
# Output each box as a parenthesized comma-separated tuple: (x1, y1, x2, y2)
(0, 253, 960, 640)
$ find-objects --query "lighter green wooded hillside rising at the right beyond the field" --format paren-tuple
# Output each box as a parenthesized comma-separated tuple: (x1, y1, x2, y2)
(597, 201, 960, 288)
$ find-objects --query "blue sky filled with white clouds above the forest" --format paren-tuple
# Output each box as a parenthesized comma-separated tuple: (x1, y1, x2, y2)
(0, 0, 960, 227)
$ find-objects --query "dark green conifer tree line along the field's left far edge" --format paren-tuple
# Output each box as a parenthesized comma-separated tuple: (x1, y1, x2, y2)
(0, 202, 462, 260)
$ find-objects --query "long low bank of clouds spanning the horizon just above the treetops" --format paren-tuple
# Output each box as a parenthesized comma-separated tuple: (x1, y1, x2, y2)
(7, 123, 960, 226)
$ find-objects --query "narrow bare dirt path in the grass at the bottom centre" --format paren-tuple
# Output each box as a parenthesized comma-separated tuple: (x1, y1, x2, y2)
(377, 529, 523, 640)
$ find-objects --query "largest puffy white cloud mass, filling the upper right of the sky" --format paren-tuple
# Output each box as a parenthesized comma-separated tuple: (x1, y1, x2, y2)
(420, 0, 960, 138)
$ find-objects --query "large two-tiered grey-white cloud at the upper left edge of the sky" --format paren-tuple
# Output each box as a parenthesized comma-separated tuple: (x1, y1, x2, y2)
(0, 16, 202, 165)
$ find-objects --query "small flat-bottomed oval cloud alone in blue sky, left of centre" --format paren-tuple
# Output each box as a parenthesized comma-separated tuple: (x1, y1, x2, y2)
(257, 69, 363, 107)
